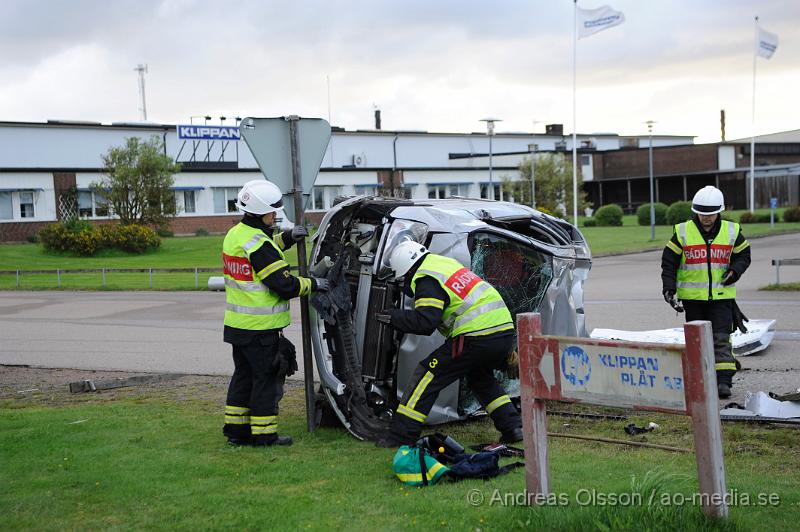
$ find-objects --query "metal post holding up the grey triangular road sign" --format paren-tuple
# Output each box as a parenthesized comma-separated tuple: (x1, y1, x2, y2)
(286, 115, 316, 432)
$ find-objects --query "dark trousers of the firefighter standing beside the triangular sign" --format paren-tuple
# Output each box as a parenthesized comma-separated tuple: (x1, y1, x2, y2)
(222, 332, 285, 441)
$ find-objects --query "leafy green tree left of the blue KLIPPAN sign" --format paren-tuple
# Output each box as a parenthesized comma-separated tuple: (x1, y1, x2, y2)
(89, 135, 180, 227)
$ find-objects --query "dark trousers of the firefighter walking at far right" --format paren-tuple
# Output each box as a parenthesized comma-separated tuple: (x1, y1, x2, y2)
(683, 299, 738, 386)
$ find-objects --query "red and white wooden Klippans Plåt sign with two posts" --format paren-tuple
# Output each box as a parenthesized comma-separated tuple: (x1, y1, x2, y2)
(517, 313, 728, 518)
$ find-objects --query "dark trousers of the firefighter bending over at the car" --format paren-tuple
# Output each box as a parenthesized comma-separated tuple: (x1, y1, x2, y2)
(391, 331, 522, 443)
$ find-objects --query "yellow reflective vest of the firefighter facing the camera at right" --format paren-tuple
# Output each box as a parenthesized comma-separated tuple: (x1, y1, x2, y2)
(675, 220, 739, 301)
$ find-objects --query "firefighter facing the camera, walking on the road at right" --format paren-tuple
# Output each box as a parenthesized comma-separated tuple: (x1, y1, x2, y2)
(661, 186, 750, 399)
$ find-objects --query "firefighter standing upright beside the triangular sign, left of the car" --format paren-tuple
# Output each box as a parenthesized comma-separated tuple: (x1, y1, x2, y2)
(222, 179, 328, 447)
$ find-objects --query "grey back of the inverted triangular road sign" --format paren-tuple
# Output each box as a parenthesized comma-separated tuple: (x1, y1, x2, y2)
(240, 116, 331, 221)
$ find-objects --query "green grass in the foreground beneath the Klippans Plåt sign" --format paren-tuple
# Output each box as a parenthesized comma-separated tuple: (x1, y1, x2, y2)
(0, 381, 800, 531)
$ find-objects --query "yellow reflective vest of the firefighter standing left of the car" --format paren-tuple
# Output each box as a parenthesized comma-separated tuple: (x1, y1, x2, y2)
(222, 223, 291, 330)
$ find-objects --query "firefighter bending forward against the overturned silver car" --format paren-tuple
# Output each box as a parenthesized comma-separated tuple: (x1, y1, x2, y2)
(377, 240, 522, 447)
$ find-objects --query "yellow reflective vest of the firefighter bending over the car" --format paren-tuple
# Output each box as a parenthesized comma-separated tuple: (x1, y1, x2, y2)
(411, 253, 514, 338)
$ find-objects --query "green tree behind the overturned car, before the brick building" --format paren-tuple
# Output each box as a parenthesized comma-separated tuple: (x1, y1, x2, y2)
(510, 153, 592, 218)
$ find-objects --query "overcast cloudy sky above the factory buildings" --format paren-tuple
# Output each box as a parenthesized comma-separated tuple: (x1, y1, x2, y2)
(0, 0, 800, 142)
